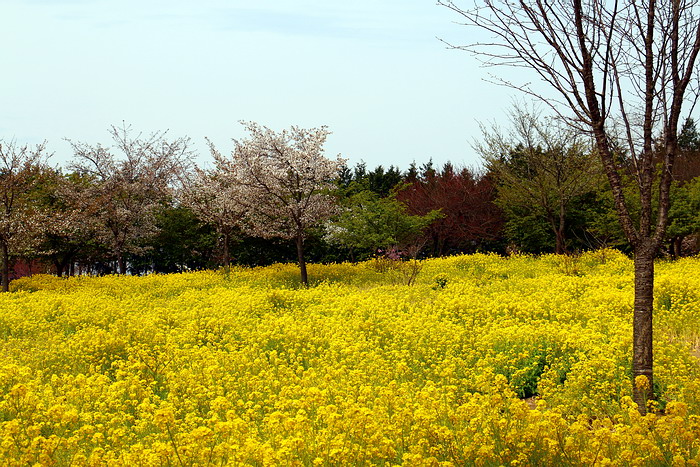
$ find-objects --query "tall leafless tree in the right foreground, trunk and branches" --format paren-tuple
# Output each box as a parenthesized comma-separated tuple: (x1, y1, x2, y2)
(438, 0, 700, 413)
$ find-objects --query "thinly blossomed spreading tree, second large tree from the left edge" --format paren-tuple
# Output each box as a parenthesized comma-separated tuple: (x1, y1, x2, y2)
(71, 125, 192, 274)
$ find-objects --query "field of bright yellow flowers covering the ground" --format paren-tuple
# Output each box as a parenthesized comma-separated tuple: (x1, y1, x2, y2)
(0, 250, 700, 466)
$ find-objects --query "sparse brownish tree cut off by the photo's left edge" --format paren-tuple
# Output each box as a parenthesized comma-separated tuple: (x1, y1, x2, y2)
(0, 140, 46, 292)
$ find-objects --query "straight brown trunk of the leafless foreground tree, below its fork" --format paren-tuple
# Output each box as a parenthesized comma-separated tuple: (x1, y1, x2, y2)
(632, 245, 655, 414)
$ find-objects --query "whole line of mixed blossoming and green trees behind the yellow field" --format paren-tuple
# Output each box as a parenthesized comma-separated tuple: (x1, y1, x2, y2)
(0, 112, 700, 290)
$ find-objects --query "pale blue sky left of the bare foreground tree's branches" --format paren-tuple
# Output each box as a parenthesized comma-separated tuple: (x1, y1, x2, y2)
(0, 0, 513, 170)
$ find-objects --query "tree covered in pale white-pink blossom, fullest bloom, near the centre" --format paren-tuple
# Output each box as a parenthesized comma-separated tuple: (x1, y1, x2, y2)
(211, 122, 344, 285)
